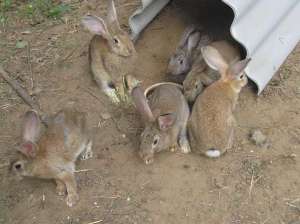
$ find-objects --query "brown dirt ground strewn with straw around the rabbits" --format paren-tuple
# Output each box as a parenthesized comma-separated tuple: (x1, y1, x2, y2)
(0, 0, 300, 224)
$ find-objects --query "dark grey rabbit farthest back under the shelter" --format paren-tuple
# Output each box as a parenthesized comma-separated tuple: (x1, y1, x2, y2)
(167, 25, 211, 83)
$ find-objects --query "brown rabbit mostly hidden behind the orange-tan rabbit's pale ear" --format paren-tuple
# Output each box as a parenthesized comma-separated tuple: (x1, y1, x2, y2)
(183, 40, 241, 103)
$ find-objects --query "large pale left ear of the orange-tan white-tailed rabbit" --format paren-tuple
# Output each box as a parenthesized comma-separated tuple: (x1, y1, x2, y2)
(201, 46, 228, 75)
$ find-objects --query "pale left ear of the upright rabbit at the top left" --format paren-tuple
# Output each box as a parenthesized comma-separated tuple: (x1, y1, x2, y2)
(81, 15, 109, 39)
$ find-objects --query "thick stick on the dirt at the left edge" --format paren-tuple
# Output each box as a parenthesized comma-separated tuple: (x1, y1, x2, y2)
(0, 65, 42, 114)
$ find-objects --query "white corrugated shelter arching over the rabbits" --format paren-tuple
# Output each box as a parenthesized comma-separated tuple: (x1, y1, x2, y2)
(129, 0, 300, 93)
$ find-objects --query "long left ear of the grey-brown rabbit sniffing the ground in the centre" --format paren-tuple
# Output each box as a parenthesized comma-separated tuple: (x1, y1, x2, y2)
(131, 86, 154, 122)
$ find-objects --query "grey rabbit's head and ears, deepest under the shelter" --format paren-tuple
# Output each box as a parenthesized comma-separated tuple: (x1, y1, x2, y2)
(167, 26, 200, 76)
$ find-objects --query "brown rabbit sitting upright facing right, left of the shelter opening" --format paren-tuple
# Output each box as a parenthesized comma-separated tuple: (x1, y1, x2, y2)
(82, 0, 137, 104)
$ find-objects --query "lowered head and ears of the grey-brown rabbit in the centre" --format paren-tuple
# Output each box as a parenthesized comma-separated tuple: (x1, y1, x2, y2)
(132, 87, 176, 164)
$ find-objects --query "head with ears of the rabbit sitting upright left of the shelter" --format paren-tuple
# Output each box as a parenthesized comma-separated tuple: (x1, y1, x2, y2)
(82, 0, 135, 57)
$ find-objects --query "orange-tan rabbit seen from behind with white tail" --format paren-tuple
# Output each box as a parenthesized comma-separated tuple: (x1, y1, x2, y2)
(188, 45, 251, 158)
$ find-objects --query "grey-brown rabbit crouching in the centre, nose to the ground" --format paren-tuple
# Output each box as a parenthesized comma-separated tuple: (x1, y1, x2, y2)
(132, 83, 190, 164)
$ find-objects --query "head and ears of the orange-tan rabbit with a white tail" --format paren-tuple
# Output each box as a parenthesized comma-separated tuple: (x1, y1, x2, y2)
(201, 46, 251, 93)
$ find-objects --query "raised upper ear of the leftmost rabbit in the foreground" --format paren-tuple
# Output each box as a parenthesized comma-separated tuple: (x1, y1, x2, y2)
(23, 111, 41, 143)
